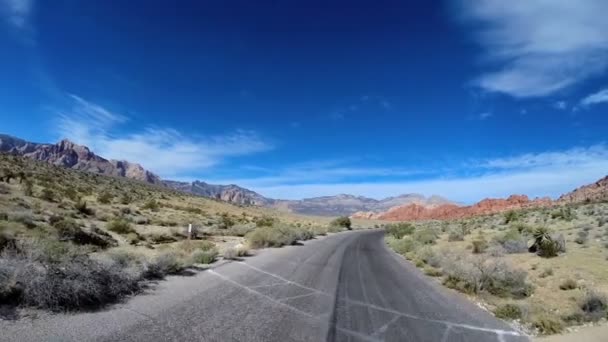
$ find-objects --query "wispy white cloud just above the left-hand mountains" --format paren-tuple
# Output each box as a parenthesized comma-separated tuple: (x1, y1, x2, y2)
(57, 95, 272, 177)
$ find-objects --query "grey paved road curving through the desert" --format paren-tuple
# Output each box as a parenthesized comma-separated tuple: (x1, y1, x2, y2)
(0, 230, 527, 342)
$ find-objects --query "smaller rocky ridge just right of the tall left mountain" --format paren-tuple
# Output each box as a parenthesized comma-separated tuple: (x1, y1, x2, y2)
(164, 181, 275, 206)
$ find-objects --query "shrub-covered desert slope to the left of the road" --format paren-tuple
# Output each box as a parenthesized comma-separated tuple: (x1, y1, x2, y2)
(0, 154, 351, 311)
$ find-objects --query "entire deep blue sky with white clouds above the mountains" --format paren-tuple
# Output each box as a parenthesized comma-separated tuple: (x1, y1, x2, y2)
(0, 0, 608, 202)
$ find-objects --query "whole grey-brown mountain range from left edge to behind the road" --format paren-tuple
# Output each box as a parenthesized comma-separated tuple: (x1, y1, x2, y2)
(0, 134, 455, 216)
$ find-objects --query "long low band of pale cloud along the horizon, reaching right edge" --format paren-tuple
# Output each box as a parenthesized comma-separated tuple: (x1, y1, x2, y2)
(217, 144, 608, 203)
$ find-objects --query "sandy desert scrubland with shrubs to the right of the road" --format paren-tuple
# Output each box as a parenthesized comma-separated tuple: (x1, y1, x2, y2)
(385, 202, 608, 334)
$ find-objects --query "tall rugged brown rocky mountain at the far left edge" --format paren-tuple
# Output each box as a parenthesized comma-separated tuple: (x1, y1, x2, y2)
(0, 135, 162, 184)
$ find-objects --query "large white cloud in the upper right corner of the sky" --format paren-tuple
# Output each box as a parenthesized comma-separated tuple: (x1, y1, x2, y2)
(459, 0, 608, 97)
